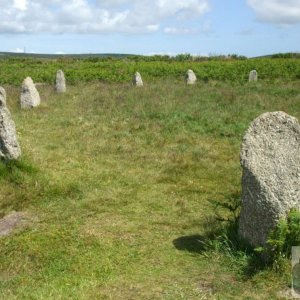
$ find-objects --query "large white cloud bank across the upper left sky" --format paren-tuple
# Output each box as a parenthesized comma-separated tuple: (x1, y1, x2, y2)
(0, 0, 210, 33)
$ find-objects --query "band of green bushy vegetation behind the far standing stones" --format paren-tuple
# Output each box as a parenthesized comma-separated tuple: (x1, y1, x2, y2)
(0, 54, 300, 86)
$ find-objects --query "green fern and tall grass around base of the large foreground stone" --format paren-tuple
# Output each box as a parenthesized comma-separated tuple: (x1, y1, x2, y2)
(206, 193, 300, 272)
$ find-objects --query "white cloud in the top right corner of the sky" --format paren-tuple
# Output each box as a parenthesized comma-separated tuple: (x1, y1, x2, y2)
(247, 0, 300, 25)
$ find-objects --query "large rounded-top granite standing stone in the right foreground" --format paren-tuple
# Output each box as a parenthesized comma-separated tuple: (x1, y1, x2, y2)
(239, 111, 300, 246)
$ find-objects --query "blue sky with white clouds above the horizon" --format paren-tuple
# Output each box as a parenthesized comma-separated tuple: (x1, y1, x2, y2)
(0, 0, 300, 57)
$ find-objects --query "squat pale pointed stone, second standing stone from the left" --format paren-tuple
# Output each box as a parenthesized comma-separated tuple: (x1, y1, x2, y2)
(20, 77, 41, 108)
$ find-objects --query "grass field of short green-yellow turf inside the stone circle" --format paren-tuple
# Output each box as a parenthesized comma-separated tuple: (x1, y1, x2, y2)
(0, 79, 300, 300)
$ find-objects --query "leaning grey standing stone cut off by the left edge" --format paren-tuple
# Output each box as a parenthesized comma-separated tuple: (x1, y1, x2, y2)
(0, 89, 21, 160)
